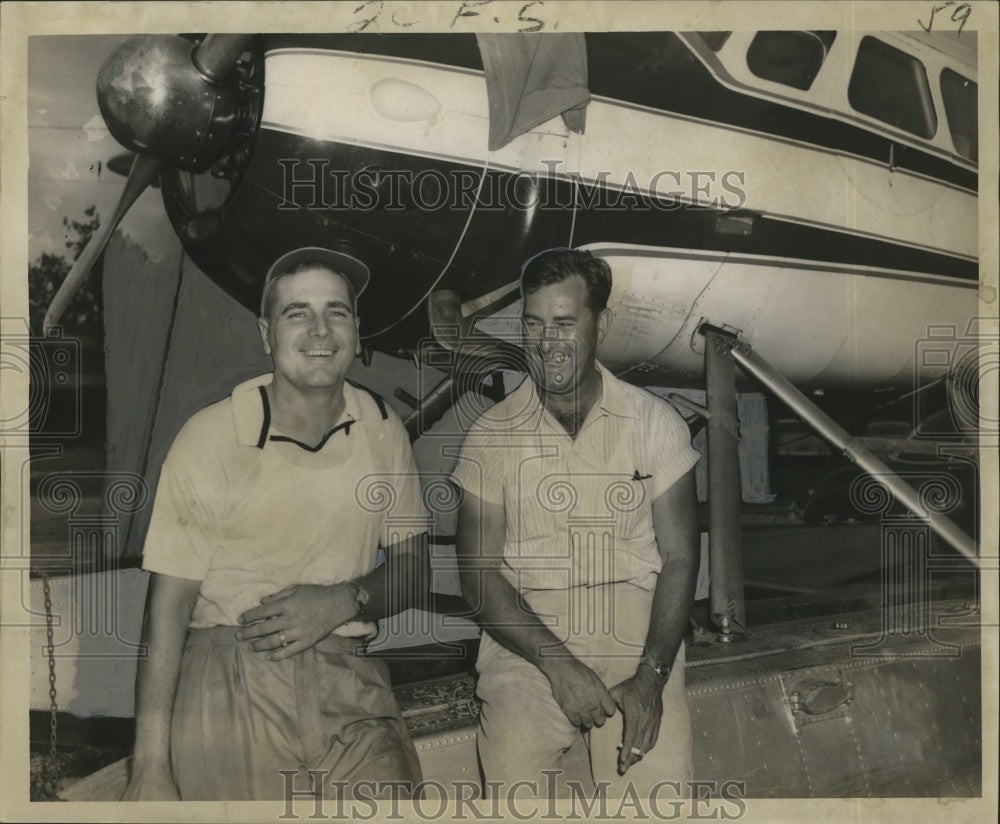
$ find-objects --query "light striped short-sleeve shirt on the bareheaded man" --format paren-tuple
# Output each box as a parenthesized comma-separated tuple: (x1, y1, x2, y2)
(452, 364, 700, 592)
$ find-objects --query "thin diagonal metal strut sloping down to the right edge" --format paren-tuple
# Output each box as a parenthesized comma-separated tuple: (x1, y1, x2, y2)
(728, 332, 979, 573)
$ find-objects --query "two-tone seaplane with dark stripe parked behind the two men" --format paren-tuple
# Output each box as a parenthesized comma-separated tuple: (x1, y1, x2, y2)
(29, 30, 982, 799)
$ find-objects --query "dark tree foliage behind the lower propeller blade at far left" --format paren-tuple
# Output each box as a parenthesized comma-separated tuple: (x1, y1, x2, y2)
(28, 205, 104, 335)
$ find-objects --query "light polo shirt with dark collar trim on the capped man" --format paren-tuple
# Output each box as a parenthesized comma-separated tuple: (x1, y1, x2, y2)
(143, 375, 428, 636)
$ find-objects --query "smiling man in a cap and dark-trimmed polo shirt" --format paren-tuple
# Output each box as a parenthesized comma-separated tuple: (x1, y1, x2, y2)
(123, 248, 429, 801)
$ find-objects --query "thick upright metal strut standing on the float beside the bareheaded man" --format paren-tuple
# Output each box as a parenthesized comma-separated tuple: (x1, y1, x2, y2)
(701, 325, 746, 642)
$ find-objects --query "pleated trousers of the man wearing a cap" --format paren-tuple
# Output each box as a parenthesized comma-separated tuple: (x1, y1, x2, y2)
(170, 627, 420, 801)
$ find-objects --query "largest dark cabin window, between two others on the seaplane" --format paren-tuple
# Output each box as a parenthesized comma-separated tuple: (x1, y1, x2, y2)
(847, 36, 937, 137)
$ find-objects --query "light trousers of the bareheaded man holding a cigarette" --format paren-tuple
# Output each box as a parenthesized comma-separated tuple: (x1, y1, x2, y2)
(477, 584, 691, 798)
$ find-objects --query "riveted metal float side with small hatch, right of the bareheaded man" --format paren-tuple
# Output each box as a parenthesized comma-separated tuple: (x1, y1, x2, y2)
(687, 602, 982, 798)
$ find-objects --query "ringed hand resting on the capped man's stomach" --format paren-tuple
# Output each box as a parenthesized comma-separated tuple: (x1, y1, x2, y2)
(236, 584, 358, 661)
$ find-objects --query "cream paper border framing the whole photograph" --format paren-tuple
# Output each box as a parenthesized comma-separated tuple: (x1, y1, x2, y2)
(0, 0, 1000, 824)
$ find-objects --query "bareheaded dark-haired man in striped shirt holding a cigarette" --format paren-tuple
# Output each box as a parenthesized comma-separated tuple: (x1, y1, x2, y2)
(452, 249, 699, 798)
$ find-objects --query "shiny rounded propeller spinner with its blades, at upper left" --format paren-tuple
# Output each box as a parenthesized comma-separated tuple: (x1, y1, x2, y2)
(42, 35, 253, 334)
